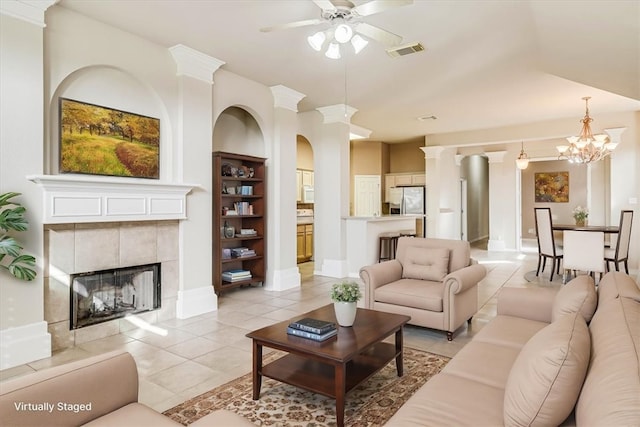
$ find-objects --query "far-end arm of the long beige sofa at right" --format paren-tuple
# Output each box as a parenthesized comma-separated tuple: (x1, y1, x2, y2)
(498, 288, 558, 323)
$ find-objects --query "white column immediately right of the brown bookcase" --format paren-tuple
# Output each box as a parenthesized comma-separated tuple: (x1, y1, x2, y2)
(265, 85, 305, 291)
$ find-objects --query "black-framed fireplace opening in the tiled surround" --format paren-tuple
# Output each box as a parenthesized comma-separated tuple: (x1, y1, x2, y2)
(70, 263, 160, 330)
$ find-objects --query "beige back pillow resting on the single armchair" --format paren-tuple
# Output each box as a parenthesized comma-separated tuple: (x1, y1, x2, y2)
(402, 246, 449, 282)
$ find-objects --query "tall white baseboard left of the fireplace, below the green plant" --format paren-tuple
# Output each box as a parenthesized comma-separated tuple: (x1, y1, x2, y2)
(0, 321, 51, 370)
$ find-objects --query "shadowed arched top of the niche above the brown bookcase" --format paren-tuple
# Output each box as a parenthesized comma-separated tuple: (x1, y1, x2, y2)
(213, 106, 267, 157)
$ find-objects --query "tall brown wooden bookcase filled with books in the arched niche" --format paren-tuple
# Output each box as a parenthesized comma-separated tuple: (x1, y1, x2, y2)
(213, 152, 267, 296)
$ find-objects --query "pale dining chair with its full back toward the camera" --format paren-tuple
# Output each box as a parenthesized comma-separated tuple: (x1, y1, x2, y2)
(562, 230, 605, 284)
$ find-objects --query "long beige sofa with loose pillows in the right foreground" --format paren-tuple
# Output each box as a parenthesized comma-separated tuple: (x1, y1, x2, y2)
(387, 272, 640, 427)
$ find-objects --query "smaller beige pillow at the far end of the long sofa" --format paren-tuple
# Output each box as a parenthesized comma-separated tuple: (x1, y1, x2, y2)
(551, 276, 598, 323)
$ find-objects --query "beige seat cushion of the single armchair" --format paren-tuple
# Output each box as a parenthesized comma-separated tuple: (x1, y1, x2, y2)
(375, 279, 444, 312)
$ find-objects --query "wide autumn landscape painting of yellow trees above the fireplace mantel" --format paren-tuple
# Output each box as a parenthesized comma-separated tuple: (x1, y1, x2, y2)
(60, 98, 160, 179)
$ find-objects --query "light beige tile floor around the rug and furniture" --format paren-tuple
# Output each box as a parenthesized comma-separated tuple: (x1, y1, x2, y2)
(0, 245, 558, 411)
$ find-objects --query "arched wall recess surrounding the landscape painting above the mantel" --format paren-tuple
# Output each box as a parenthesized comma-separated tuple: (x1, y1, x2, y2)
(44, 65, 174, 181)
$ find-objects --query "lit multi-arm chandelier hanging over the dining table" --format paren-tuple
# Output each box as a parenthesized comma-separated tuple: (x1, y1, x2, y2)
(556, 96, 618, 163)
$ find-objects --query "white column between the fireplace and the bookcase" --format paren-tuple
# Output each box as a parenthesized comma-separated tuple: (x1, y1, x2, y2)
(169, 45, 224, 319)
